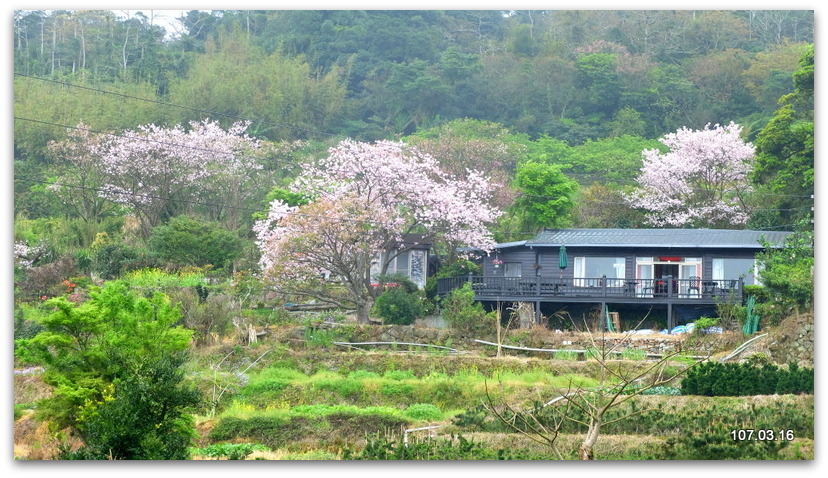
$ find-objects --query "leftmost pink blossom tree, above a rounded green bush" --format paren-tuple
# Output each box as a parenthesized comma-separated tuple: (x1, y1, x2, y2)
(96, 120, 262, 236)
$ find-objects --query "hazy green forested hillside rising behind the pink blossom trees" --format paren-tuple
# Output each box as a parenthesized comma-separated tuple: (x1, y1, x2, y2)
(14, 11, 813, 226)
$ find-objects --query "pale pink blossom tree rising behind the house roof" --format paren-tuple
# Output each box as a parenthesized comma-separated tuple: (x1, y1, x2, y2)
(628, 122, 755, 228)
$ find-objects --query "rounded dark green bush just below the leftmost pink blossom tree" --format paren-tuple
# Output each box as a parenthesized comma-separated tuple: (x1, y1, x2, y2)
(149, 216, 242, 269)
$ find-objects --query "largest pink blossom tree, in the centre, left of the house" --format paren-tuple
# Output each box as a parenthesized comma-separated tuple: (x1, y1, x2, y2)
(255, 140, 500, 323)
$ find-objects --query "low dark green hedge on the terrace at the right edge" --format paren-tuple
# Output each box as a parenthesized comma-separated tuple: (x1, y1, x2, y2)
(681, 362, 814, 396)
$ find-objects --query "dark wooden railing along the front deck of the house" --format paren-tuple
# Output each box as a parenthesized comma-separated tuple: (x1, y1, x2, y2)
(437, 276, 744, 300)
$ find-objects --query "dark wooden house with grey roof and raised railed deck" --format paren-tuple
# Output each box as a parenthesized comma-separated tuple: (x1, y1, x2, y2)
(438, 229, 790, 329)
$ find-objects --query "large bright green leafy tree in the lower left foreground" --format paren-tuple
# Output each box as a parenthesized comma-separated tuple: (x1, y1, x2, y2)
(16, 281, 195, 457)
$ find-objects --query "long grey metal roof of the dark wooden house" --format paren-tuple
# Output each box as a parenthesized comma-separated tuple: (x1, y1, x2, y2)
(520, 229, 791, 249)
